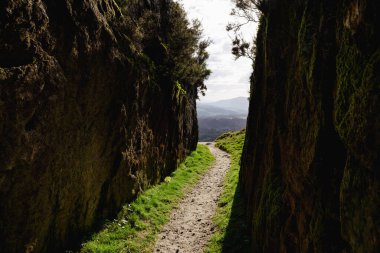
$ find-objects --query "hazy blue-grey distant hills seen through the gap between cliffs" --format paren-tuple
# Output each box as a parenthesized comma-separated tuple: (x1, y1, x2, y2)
(197, 97, 249, 141)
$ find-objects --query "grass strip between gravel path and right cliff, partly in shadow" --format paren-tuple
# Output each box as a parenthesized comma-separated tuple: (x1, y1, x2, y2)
(205, 131, 251, 253)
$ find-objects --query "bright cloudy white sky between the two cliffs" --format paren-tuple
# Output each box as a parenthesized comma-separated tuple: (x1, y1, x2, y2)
(177, 0, 257, 102)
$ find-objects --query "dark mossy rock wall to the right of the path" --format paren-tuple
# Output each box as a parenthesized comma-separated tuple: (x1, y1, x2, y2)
(241, 0, 380, 253)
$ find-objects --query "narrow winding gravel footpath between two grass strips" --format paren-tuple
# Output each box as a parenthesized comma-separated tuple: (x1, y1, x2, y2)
(154, 143, 230, 253)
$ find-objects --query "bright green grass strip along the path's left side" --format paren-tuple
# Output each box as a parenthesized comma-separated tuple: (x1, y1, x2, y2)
(81, 145, 214, 253)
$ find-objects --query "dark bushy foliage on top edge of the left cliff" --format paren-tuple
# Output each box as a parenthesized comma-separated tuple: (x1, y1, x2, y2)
(117, 0, 211, 98)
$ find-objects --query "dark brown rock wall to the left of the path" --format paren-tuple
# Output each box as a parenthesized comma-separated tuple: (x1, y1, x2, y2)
(0, 0, 197, 252)
